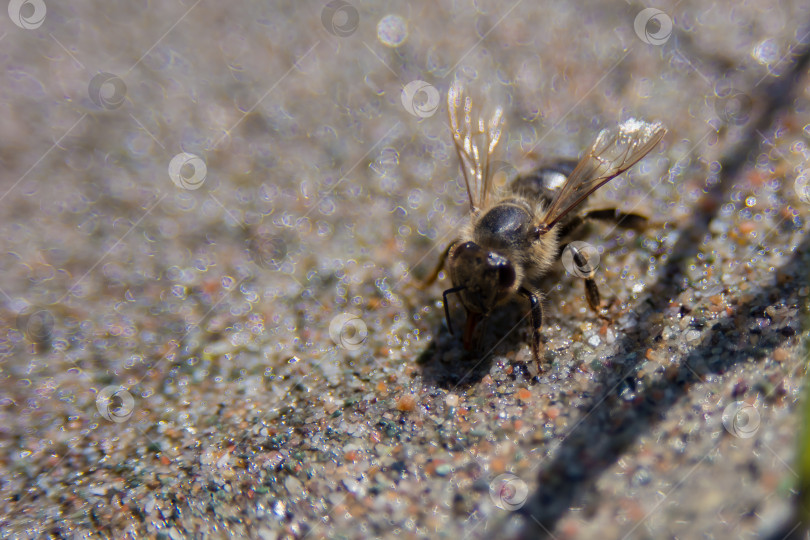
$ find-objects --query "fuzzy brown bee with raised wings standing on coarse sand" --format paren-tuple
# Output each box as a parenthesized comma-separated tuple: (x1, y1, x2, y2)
(424, 86, 666, 371)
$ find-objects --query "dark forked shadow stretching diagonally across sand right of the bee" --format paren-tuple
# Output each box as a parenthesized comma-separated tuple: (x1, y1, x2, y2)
(519, 44, 810, 538)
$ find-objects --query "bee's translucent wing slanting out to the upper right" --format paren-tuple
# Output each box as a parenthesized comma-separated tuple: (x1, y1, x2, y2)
(541, 118, 667, 230)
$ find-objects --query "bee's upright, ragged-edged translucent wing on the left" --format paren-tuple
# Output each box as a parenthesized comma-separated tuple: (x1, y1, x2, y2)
(447, 85, 503, 213)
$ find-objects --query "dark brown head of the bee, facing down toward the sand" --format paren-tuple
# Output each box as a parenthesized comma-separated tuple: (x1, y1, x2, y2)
(447, 242, 518, 316)
